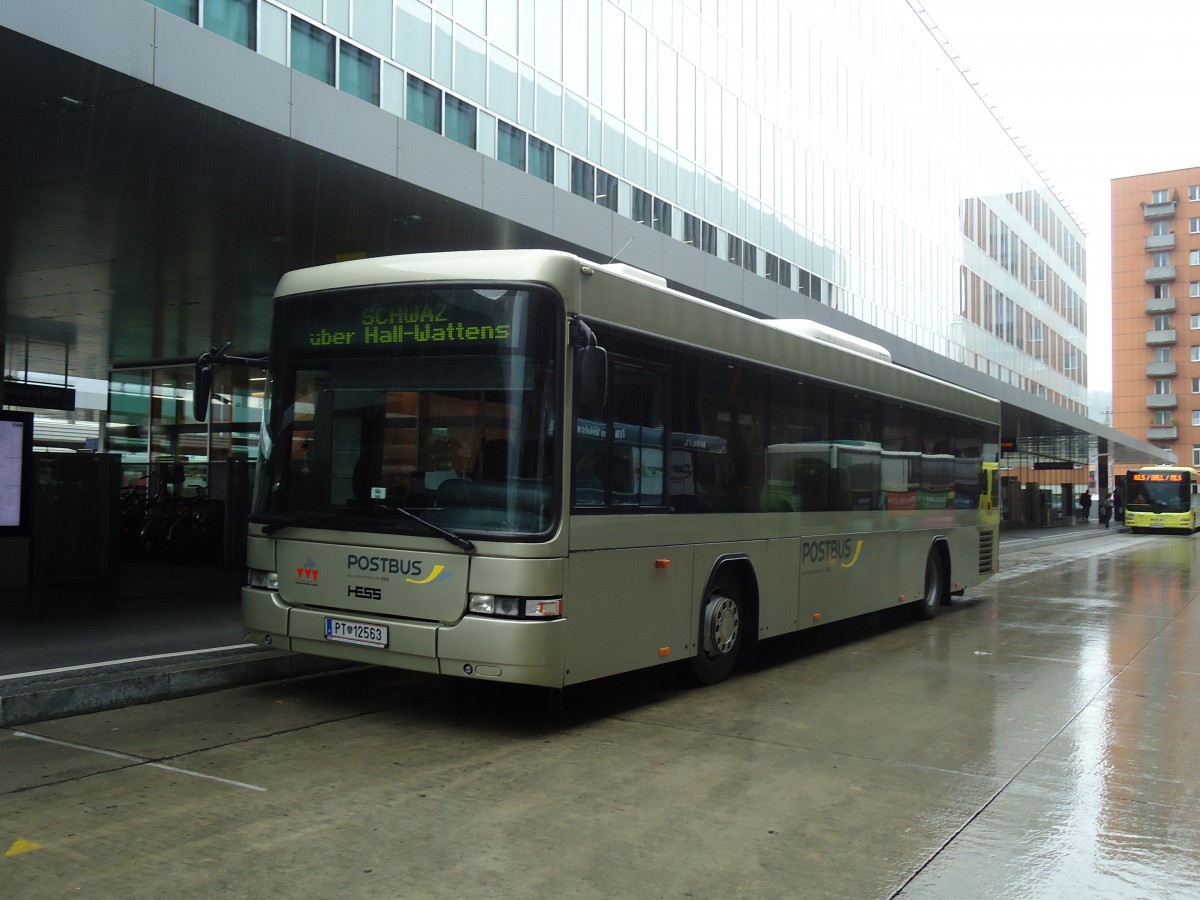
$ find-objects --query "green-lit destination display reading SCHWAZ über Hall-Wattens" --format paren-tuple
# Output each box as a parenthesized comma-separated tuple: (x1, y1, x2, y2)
(288, 289, 518, 349)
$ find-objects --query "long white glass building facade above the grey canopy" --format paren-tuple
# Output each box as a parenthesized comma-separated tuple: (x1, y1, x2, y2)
(155, 0, 1087, 413)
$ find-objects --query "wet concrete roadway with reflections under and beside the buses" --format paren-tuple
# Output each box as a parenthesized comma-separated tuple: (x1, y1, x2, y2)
(0, 532, 1200, 898)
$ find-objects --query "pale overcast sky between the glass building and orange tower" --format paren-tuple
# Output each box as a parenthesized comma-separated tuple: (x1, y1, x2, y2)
(914, 0, 1200, 390)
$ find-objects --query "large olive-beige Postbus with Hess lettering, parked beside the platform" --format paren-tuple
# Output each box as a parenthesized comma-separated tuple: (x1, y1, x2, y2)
(208, 251, 1000, 688)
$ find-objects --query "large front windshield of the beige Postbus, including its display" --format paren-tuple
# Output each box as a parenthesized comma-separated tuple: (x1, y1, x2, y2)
(251, 284, 564, 539)
